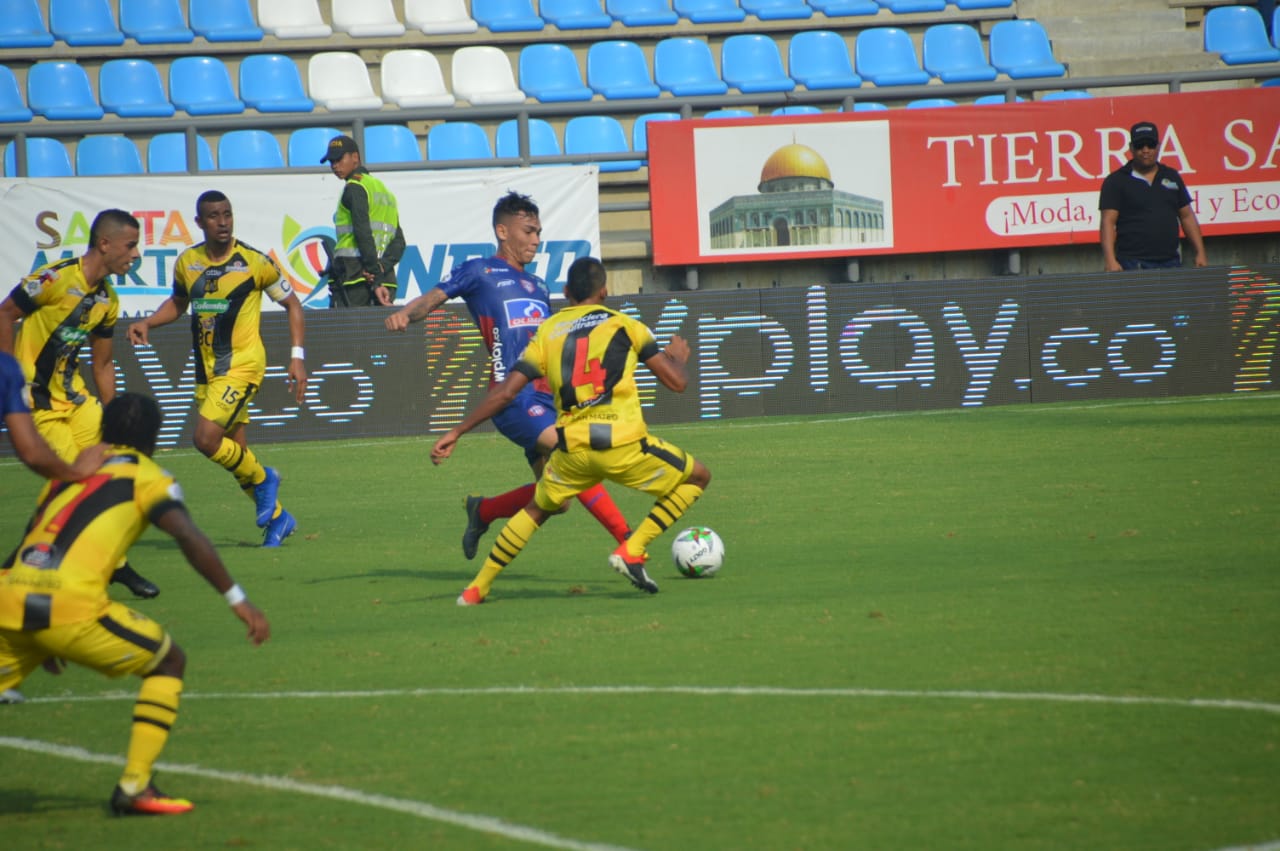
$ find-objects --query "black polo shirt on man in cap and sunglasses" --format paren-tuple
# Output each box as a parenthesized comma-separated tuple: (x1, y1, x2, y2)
(1098, 160, 1192, 262)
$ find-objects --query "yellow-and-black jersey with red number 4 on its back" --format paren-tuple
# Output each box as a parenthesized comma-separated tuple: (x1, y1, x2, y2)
(515, 305, 659, 452)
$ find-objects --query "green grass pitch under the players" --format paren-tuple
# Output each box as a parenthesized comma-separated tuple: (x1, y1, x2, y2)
(0, 394, 1280, 851)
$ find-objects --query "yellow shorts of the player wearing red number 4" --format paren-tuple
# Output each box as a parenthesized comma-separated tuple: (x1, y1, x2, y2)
(534, 434, 694, 512)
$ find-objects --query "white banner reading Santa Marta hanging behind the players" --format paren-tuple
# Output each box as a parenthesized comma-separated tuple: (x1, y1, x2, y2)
(0, 166, 600, 316)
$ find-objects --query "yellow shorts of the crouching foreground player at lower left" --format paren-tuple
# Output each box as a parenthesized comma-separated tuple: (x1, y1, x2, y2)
(0, 603, 173, 691)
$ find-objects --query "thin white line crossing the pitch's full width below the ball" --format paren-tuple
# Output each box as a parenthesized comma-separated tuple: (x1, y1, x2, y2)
(17, 686, 1280, 711)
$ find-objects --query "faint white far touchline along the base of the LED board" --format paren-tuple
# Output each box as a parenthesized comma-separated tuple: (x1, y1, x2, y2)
(0, 392, 1280, 470)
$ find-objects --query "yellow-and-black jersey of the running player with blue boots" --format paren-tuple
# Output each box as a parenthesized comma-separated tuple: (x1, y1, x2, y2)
(173, 241, 293, 384)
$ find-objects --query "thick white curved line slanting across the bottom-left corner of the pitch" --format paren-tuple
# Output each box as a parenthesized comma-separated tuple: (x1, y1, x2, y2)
(0, 736, 640, 851)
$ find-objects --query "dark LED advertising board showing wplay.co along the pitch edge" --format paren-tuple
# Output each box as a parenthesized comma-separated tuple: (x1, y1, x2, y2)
(92, 265, 1280, 449)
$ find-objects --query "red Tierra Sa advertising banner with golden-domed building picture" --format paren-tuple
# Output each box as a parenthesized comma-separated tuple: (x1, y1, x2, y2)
(648, 88, 1280, 265)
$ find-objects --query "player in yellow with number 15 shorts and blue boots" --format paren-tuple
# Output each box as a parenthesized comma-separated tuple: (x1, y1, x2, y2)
(129, 189, 307, 546)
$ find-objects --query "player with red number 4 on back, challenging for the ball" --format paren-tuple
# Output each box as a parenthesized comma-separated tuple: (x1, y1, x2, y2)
(431, 257, 712, 605)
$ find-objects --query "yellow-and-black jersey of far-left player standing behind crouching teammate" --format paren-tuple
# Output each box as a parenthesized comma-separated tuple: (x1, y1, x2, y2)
(10, 257, 120, 411)
